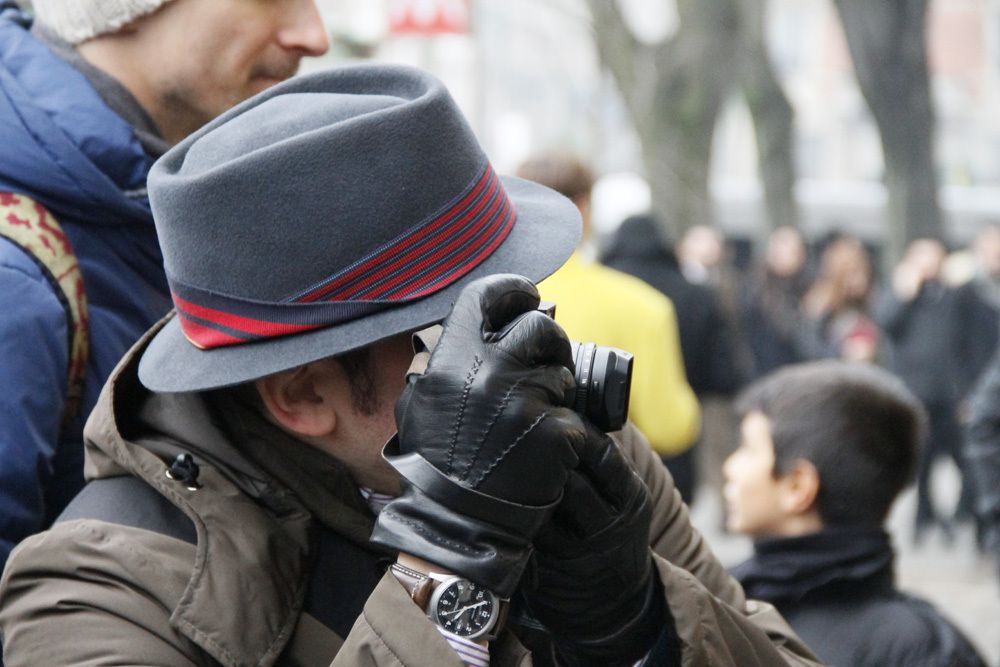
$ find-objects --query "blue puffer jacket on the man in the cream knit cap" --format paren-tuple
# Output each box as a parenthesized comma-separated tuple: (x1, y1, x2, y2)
(0, 1, 170, 566)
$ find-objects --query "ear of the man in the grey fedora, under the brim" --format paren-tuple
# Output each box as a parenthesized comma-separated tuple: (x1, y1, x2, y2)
(255, 359, 342, 437)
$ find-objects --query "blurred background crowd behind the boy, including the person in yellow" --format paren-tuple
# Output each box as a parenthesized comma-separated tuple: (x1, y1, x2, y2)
(520, 154, 1000, 549)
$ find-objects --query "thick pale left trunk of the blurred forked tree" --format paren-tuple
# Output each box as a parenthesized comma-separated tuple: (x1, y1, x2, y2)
(588, 0, 739, 237)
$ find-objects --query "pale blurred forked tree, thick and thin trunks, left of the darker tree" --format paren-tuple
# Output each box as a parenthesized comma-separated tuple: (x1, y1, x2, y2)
(588, 0, 798, 236)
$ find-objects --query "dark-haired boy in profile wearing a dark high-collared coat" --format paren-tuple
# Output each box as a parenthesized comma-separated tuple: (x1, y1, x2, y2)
(723, 361, 985, 667)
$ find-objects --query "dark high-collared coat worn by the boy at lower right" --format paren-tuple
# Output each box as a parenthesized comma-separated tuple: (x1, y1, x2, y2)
(733, 528, 985, 667)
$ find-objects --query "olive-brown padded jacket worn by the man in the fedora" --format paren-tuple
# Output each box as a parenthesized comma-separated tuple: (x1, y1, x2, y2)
(0, 320, 818, 667)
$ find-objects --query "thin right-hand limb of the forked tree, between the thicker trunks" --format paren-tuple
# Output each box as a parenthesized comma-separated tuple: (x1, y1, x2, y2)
(741, 0, 799, 229)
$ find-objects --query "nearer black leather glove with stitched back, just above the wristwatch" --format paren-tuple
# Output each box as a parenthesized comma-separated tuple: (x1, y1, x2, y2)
(372, 275, 586, 597)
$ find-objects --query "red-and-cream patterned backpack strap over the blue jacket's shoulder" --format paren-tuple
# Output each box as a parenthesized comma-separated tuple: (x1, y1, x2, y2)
(0, 192, 90, 429)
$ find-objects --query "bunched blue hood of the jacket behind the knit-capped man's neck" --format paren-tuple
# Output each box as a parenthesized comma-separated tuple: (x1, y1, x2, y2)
(0, 2, 159, 223)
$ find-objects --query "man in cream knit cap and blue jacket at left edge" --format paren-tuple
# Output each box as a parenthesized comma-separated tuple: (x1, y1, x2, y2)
(0, 0, 328, 565)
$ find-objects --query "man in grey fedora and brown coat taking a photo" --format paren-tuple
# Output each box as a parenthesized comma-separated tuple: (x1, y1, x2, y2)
(0, 66, 813, 667)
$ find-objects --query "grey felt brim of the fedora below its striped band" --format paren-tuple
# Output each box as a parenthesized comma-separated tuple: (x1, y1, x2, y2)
(139, 176, 580, 392)
